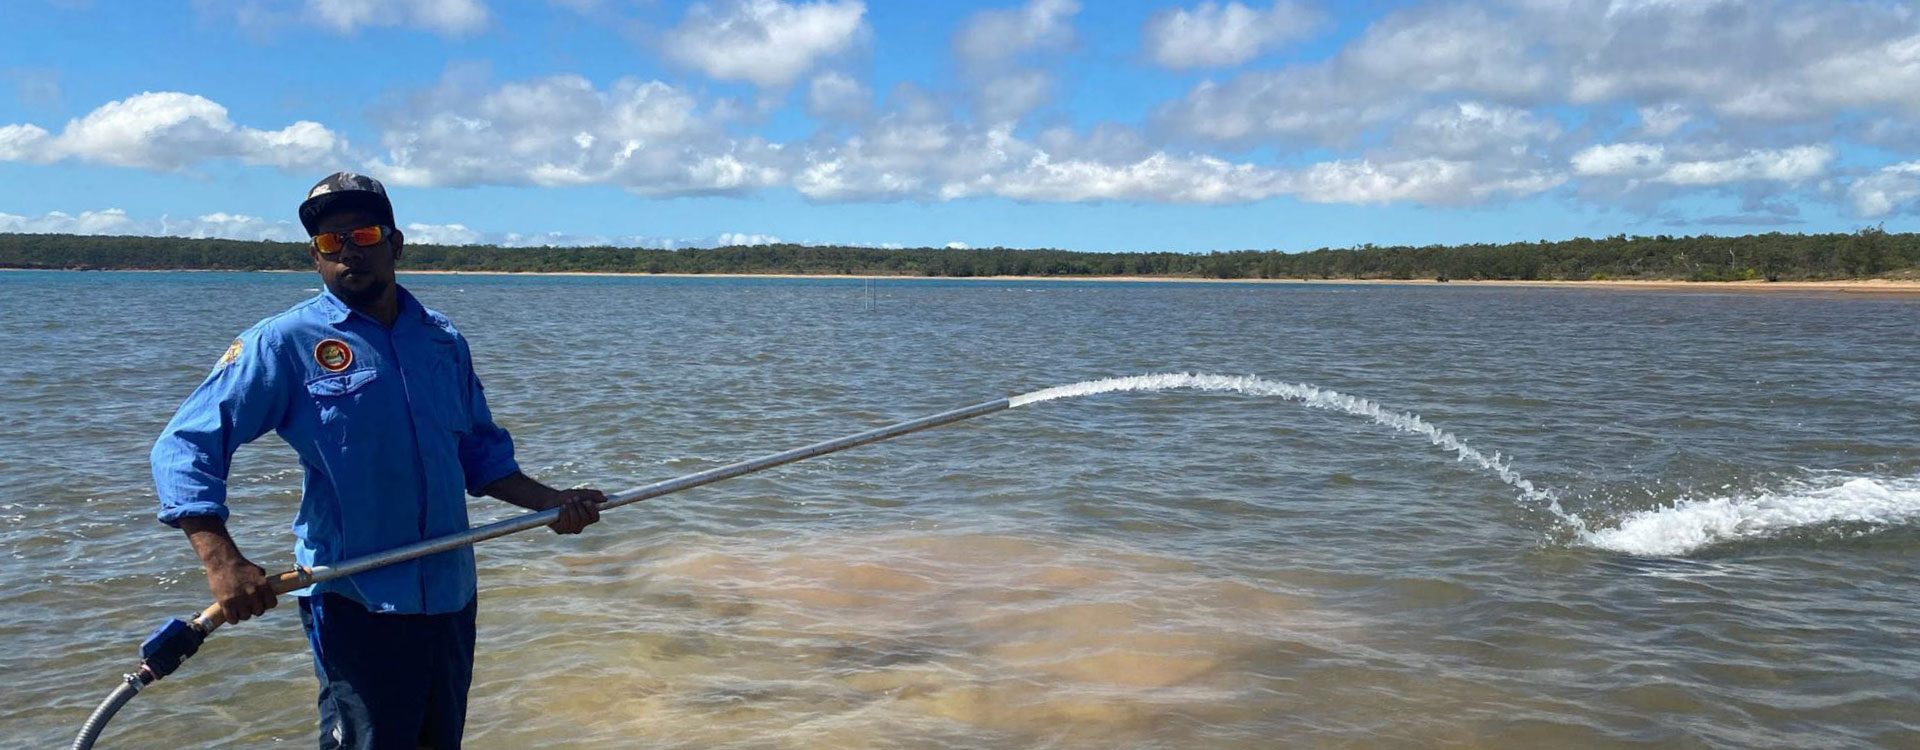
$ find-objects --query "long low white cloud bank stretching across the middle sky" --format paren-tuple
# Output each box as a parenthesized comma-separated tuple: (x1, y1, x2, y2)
(353, 75, 1565, 210)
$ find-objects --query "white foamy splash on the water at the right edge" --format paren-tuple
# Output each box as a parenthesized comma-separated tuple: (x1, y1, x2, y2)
(1580, 478, 1920, 556)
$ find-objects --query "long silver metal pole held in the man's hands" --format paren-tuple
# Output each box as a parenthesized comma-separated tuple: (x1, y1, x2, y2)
(192, 399, 1012, 633)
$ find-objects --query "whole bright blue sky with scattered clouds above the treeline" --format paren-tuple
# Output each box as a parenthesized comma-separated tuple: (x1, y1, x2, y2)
(0, 0, 1920, 251)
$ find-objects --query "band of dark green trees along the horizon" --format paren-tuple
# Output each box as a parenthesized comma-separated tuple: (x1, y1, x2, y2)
(0, 226, 1920, 282)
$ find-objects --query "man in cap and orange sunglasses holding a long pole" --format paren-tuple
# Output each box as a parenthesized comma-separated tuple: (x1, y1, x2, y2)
(152, 173, 605, 748)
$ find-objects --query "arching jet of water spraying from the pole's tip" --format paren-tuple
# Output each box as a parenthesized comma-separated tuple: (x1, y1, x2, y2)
(1008, 372, 1588, 537)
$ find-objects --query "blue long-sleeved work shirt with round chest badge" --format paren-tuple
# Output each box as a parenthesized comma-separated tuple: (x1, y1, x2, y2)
(152, 290, 518, 614)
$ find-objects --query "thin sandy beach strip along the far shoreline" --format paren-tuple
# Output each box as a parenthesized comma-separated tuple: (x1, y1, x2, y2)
(15, 269, 1920, 297)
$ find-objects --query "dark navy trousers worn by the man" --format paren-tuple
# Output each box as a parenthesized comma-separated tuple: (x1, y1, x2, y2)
(300, 595, 478, 750)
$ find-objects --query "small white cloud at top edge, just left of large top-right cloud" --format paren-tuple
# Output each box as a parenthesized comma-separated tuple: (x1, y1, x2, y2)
(1140, 0, 1321, 69)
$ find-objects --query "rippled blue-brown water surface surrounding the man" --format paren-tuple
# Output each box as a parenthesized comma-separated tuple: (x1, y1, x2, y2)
(0, 272, 1920, 748)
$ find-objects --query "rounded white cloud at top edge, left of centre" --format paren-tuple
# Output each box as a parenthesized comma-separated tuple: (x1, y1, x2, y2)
(664, 0, 866, 88)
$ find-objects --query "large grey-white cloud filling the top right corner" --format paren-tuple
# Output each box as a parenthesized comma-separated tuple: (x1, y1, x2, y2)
(1158, 0, 1920, 146)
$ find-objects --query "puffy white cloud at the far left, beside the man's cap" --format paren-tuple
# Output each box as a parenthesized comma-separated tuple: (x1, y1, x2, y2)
(0, 92, 348, 171)
